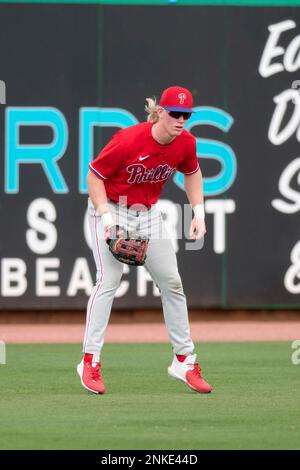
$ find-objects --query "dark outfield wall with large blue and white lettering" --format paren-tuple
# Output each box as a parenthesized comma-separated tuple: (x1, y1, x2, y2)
(0, 1, 300, 309)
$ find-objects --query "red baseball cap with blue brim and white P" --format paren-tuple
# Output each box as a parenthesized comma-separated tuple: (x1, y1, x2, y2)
(159, 86, 193, 113)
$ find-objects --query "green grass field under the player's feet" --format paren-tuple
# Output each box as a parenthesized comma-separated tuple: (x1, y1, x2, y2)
(0, 343, 300, 450)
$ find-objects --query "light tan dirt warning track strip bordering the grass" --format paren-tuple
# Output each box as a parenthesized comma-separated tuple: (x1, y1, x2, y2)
(0, 321, 300, 343)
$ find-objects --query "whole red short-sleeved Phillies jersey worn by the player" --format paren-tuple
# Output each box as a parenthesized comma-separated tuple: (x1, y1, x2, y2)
(89, 122, 199, 208)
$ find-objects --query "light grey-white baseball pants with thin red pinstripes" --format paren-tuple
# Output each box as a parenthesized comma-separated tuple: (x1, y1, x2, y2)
(83, 199, 194, 361)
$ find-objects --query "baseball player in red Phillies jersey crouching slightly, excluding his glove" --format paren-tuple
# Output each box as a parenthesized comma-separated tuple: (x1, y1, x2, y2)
(77, 86, 212, 394)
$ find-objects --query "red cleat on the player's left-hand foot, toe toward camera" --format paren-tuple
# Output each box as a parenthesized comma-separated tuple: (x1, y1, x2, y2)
(77, 354, 105, 394)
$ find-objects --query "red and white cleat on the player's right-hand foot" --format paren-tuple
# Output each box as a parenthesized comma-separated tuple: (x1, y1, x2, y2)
(168, 354, 212, 393)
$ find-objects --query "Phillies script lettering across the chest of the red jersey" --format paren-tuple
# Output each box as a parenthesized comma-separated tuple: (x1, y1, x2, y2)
(126, 163, 176, 184)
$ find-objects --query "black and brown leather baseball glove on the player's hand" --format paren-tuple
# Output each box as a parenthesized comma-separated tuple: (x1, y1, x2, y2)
(105, 225, 149, 266)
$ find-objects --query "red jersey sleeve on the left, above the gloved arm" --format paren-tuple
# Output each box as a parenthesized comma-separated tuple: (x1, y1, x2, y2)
(89, 133, 127, 180)
